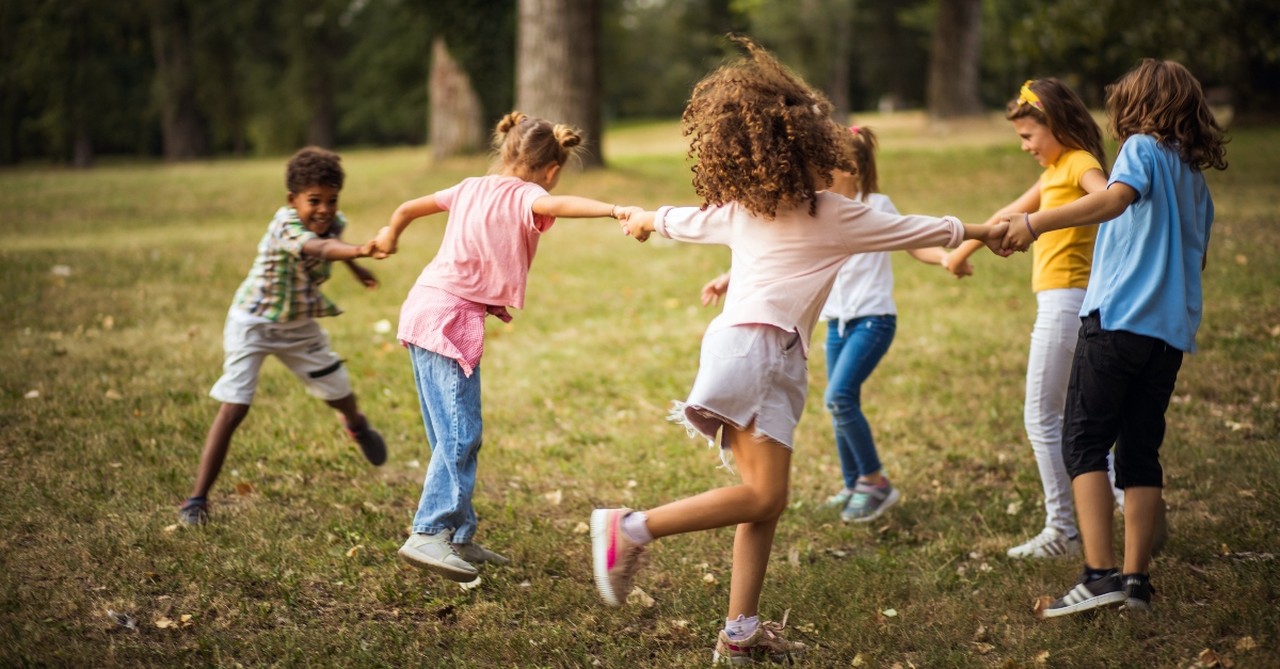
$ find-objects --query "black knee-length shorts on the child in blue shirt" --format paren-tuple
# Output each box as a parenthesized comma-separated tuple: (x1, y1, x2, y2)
(1062, 311, 1183, 489)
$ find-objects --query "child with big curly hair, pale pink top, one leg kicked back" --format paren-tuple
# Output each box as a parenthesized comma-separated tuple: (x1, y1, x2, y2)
(591, 38, 1005, 664)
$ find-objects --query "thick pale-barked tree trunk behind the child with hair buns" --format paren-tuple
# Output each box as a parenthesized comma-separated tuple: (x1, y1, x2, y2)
(516, 0, 604, 168)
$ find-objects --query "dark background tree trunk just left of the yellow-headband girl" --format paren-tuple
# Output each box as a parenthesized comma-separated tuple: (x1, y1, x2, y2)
(925, 0, 984, 119)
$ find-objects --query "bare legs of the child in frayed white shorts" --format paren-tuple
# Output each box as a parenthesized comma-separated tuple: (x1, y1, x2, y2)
(645, 427, 791, 618)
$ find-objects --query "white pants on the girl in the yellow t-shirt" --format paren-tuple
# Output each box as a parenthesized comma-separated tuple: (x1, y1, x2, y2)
(1023, 288, 1124, 536)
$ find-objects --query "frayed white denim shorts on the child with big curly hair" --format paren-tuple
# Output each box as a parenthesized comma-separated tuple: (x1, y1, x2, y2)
(671, 325, 809, 449)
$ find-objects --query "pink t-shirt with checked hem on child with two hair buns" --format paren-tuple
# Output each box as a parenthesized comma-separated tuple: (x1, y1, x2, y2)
(397, 177, 556, 376)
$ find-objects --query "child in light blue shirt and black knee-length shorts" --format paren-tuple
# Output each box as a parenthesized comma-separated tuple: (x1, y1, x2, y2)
(1004, 59, 1226, 618)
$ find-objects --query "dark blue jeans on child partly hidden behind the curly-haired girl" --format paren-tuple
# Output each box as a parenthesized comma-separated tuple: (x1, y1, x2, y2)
(823, 315, 897, 489)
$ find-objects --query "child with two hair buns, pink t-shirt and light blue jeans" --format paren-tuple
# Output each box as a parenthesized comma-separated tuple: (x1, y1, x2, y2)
(375, 111, 639, 582)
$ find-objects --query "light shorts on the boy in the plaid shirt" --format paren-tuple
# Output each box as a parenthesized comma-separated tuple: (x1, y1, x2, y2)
(209, 312, 351, 404)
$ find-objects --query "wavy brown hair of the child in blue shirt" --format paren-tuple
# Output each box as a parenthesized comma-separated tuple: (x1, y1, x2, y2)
(1107, 58, 1228, 170)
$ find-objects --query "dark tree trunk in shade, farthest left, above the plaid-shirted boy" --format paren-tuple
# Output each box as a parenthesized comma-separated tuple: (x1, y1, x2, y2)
(147, 0, 207, 160)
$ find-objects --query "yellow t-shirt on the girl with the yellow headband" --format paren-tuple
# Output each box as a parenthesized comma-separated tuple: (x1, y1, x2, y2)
(1032, 150, 1102, 293)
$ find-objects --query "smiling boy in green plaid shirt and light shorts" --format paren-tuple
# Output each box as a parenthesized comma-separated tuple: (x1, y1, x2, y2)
(178, 147, 387, 524)
